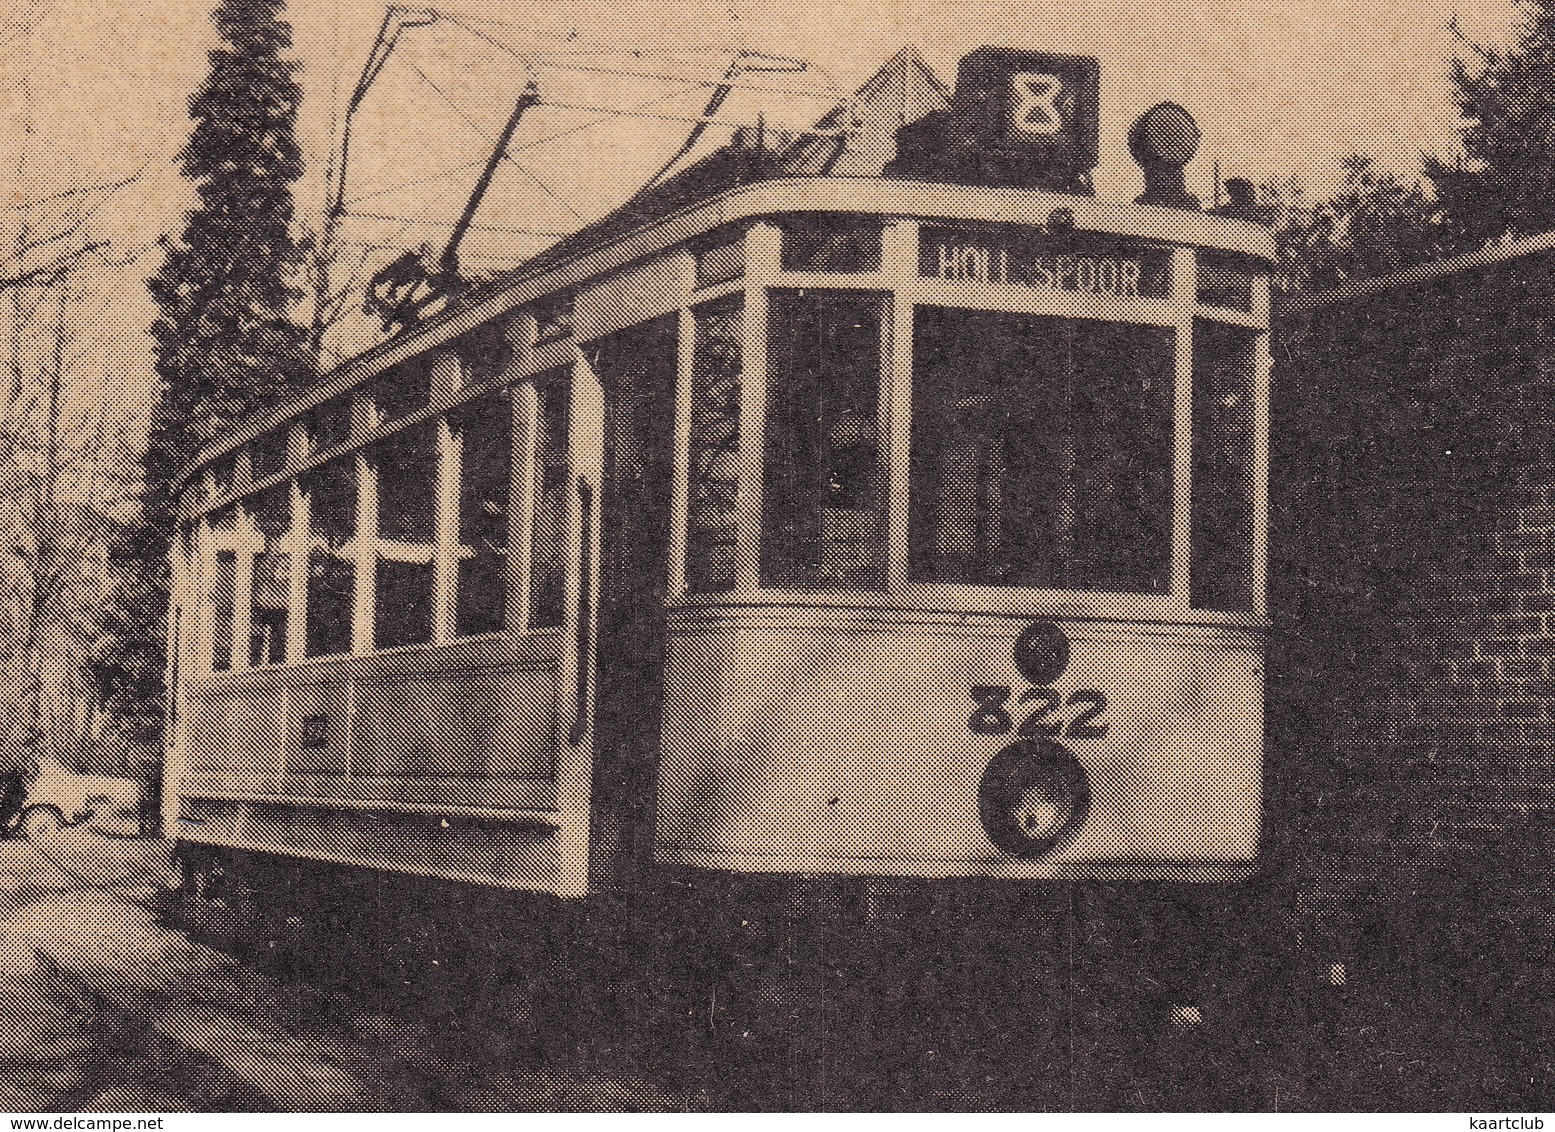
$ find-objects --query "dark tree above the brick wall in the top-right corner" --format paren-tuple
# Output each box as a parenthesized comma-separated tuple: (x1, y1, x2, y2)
(1426, 0, 1555, 249)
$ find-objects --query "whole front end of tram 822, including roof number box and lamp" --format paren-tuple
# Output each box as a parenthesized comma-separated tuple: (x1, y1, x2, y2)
(653, 48, 1272, 882)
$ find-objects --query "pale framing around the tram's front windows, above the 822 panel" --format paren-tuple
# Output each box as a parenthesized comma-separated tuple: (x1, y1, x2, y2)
(670, 219, 1270, 625)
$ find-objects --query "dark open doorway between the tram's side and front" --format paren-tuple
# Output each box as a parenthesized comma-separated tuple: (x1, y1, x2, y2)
(585, 316, 676, 883)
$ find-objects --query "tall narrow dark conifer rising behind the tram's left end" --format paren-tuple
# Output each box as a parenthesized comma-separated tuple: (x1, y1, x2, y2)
(92, 0, 314, 737)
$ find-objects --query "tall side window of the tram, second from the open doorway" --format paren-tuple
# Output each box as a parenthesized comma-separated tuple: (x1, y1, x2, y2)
(456, 390, 513, 634)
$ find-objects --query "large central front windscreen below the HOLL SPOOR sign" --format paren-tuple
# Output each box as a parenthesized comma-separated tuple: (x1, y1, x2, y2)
(910, 308, 1174, 594)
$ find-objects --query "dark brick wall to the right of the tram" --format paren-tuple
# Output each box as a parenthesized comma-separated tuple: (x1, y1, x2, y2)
(1270, 260, 1555, 891)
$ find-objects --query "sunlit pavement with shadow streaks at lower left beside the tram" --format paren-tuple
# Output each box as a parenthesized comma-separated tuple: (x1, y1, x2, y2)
(0, 829, 689, 1112)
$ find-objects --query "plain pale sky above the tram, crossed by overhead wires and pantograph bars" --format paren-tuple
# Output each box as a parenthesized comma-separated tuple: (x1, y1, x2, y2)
(0, 0, 1516, 416)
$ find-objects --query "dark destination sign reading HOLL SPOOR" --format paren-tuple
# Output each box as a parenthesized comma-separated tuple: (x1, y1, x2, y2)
(919, 229, 1171, 299)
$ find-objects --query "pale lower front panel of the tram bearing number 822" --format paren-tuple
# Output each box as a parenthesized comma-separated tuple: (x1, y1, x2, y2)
(656, 613, 1263, 877)
